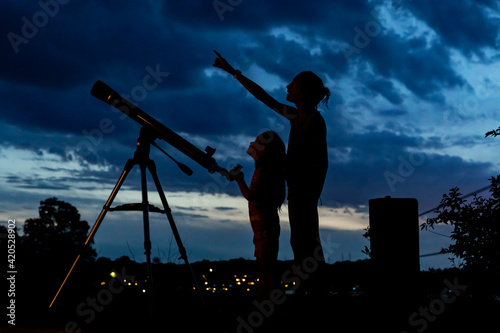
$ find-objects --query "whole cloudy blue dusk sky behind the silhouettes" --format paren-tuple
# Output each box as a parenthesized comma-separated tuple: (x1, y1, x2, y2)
(0, 0, 500, 269)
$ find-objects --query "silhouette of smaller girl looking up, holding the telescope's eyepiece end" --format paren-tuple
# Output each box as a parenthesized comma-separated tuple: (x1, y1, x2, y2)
(231, 131, 286, 299)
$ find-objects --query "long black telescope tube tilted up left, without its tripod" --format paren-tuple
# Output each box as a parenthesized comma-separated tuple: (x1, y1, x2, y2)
(90, 80, 233, 180)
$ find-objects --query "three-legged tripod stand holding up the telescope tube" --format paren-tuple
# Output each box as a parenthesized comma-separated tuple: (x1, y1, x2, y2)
(49, 127, 205, 318)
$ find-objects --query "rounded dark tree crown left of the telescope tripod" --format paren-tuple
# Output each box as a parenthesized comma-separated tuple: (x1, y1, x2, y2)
(22, 198, 96, 266)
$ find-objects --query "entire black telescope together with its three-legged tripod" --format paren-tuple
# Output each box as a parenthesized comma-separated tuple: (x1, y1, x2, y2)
(49, 80, 236, 312)
